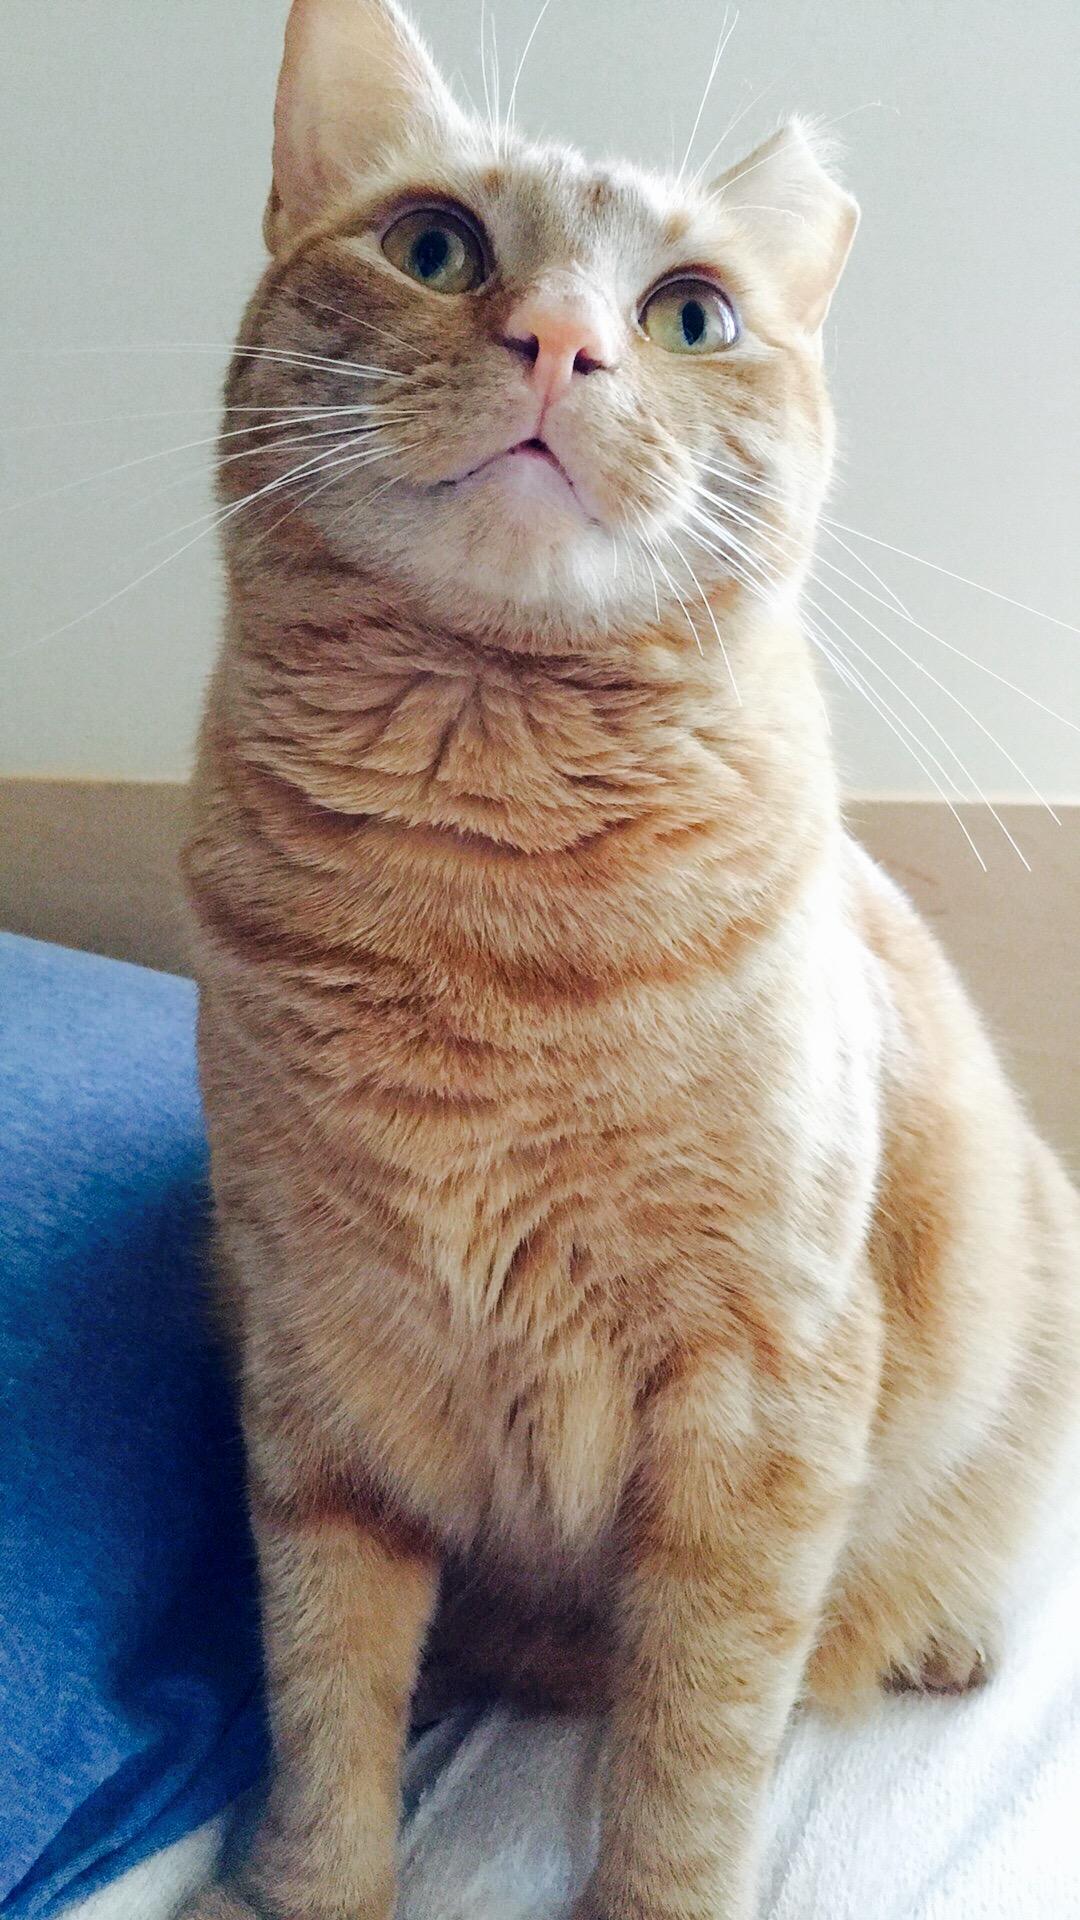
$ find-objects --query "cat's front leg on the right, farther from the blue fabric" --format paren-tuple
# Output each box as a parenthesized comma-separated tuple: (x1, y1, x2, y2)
(575, 1313, 871, 1920)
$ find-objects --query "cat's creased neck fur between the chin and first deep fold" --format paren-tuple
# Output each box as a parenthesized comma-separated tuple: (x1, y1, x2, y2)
(219, 549, 836, 860)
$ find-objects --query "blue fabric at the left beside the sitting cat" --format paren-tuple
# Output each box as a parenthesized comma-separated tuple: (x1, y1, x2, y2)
(0, 935, 265, 1920)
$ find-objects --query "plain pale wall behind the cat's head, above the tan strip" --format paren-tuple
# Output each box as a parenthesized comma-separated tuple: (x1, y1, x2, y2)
(0, 0, 1080, 795)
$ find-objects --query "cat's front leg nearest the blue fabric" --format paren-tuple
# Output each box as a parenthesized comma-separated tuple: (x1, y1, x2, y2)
(210, 1443, 438, 1920)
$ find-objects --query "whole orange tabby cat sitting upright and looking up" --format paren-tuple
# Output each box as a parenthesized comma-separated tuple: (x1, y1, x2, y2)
(186, 0, 1080, 1920)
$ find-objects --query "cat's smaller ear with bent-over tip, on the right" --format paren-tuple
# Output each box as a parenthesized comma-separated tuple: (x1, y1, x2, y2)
(711, 121, 859, 334)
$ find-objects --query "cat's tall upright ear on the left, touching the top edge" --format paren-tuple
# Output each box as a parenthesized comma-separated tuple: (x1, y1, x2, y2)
(263, 0, 463, 252)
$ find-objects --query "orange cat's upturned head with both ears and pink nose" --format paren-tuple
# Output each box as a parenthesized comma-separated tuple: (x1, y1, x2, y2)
(223, 0, 857, 637)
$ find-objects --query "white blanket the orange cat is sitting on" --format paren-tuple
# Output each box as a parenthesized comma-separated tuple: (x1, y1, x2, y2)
(65, 1450, 1080, 1920)
